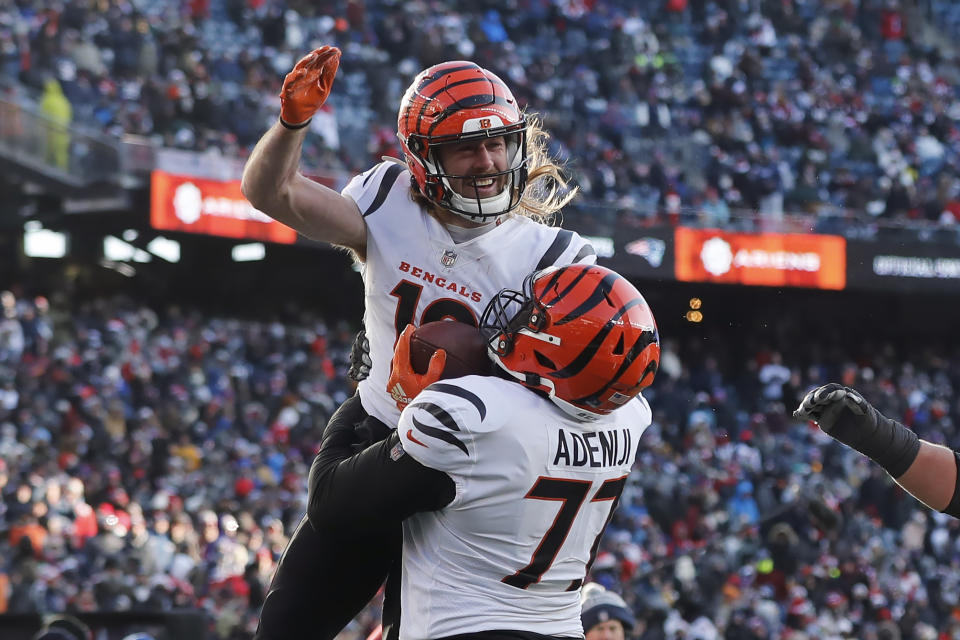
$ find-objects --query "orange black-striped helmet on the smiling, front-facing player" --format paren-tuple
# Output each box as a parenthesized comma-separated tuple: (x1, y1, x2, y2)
(397, 60, 527, 222)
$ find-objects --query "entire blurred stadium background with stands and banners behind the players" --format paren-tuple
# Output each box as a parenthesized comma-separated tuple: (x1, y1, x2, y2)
(0, 0, 960, 640)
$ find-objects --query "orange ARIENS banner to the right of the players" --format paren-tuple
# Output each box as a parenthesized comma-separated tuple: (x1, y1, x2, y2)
(674, 227, 847, 289)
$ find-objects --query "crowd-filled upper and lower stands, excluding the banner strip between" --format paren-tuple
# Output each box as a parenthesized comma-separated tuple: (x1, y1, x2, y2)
(0, 0, 960, 640)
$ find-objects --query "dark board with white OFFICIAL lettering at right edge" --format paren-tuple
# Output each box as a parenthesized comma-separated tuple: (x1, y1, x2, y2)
(847, 240, 960, 292)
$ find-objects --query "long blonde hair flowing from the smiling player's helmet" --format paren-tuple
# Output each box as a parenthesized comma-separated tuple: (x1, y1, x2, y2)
(410, 114, 580, 224)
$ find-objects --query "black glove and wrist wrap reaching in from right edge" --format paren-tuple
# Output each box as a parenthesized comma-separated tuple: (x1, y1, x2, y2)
(793, 382, 920, 478)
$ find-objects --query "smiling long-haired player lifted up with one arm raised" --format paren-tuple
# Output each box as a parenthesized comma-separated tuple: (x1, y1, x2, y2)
(243, 47, 596, 640)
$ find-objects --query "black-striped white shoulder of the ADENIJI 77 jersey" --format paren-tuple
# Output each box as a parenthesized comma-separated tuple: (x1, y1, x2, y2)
(398, 376, 500, 471)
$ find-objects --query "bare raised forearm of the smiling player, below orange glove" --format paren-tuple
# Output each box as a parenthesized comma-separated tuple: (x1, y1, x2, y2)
(241, 122, 306, 215)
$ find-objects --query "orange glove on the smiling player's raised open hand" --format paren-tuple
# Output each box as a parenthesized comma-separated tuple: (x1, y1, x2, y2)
(280, 46, 340, 129)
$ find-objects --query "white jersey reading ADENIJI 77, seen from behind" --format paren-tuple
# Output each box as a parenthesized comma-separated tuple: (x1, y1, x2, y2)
(392, 376, 651, 640)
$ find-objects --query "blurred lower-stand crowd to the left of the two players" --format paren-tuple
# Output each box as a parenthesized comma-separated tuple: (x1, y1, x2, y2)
(0, 292, 352, 637)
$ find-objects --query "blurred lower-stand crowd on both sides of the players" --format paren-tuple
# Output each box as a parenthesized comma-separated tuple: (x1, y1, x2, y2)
(0, 292, 960, 640)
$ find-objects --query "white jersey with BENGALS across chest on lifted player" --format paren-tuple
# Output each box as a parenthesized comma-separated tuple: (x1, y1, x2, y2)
(343, 162, 596, 427)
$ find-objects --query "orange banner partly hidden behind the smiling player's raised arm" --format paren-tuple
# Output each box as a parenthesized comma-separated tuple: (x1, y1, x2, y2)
(150, 171, 297, 244)
